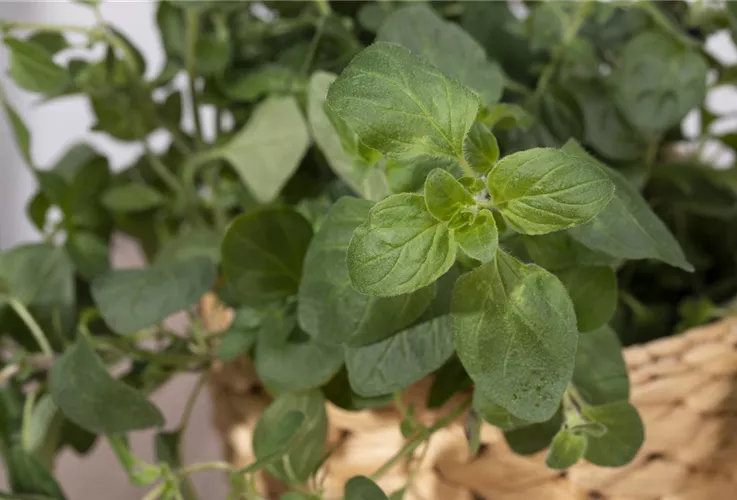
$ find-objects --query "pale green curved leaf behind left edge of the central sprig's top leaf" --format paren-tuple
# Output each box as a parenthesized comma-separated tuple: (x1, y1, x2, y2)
(307, 71, 389, 200)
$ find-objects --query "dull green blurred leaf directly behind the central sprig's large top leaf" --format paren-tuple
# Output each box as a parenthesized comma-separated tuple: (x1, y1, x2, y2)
(376, 5, 503, 106)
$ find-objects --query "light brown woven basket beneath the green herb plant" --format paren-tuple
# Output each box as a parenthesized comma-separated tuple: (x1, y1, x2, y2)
(202, 292, 737, 500)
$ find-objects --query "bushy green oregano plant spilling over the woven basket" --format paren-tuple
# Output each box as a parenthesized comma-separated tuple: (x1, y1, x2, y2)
(0, 0, 737, 500)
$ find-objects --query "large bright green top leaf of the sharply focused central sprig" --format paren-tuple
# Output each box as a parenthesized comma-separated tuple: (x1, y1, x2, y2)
(327, 42, 479, 158)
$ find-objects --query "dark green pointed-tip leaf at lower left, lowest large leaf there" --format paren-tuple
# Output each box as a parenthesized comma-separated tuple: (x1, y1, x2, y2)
(49, 337, 164, 434)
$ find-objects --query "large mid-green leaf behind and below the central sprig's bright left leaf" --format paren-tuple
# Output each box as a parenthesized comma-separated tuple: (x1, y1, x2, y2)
(297, 197, 435, 346)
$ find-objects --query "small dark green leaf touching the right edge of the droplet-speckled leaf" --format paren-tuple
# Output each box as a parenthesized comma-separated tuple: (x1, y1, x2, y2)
(556, 267, 618, 332)
